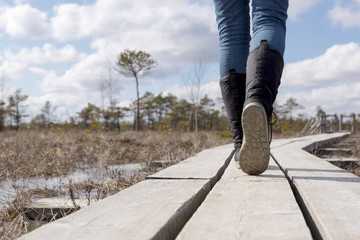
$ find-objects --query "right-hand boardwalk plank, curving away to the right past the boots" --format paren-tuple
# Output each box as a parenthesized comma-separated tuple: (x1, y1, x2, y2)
(271, 134, 360, 240)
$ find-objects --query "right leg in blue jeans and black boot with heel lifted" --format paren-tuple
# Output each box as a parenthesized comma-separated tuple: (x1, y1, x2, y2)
(239, 0, 288, 175)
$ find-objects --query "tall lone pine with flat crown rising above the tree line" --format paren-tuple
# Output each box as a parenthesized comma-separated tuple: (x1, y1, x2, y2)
(117, 50, 157, 131)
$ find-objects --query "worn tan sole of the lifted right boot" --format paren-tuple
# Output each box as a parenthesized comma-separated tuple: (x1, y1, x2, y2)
(237, 102, 270, 175)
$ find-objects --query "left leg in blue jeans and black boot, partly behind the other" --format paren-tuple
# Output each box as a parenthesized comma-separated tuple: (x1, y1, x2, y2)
(214, 0, 250, 161)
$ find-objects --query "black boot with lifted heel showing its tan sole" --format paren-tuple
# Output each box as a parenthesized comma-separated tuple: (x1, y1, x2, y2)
(239, 41, 284, 175)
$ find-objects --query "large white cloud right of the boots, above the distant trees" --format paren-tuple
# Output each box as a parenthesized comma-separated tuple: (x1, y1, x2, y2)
(277, 43, 360, 116)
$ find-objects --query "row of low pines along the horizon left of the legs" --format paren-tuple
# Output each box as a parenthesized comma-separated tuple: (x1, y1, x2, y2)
(0, 89, 227, 131)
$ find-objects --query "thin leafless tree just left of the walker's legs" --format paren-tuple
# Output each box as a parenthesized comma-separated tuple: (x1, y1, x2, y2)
(182, 60, 206, 132)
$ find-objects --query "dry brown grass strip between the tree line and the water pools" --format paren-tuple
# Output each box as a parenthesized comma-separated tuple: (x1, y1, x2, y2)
(0, 130, 231, 180)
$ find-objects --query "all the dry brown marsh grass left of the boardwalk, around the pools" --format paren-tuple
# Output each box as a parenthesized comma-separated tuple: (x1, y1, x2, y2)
(0, 129, 232, 239)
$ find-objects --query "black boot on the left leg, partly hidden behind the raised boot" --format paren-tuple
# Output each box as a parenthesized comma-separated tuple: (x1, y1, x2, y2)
(220, 69, 246, 163)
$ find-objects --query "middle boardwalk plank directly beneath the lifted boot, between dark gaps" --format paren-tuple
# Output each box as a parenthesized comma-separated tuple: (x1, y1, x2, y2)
(176, 158, 312, 240)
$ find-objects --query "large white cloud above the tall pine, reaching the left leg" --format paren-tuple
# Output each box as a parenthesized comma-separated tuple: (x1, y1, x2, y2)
(51, 0, 217, 62)
